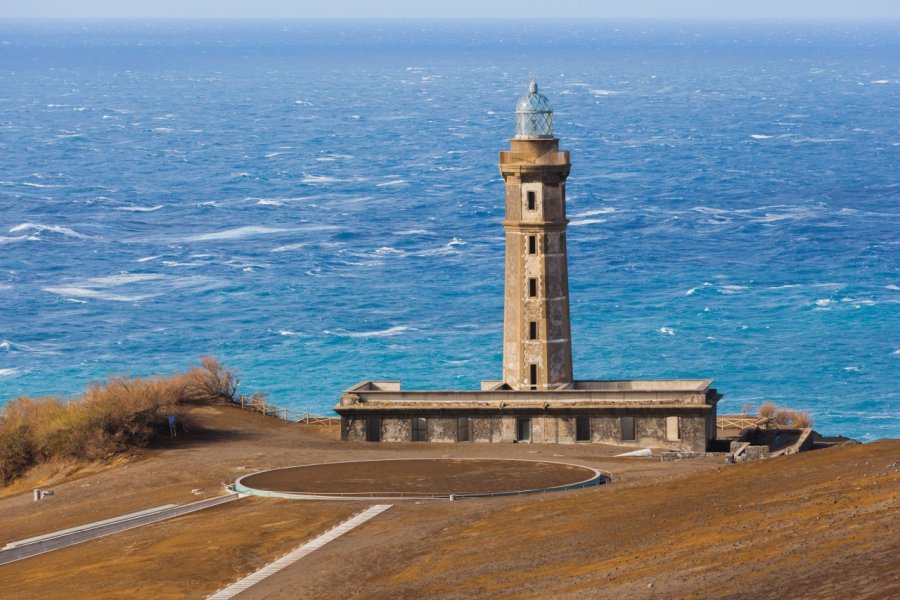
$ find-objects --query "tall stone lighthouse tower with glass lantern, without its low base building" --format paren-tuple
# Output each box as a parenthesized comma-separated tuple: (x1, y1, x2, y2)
(500, 81, 572, 390)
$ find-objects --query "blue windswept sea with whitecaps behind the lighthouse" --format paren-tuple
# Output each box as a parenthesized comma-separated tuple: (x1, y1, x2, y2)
(0, 21, 900, 440)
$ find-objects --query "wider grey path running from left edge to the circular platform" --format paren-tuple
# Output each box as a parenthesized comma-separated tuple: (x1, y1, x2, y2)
(0, 494, 242, 565)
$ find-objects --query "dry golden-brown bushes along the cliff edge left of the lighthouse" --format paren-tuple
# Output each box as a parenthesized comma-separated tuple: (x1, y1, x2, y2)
(0, 356, 237, 485)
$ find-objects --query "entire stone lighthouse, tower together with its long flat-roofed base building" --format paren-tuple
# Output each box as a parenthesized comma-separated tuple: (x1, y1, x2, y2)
(334, 82, 721, 452)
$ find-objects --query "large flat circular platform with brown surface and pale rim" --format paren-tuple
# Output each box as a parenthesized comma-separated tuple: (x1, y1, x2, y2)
(234, 458, 609, 499)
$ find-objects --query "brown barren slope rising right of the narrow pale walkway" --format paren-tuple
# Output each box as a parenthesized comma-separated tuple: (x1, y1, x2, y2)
(239, 440, 900, 598)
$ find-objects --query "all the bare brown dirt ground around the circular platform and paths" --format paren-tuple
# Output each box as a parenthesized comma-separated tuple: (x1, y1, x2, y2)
(0, 407, 900, 599)
